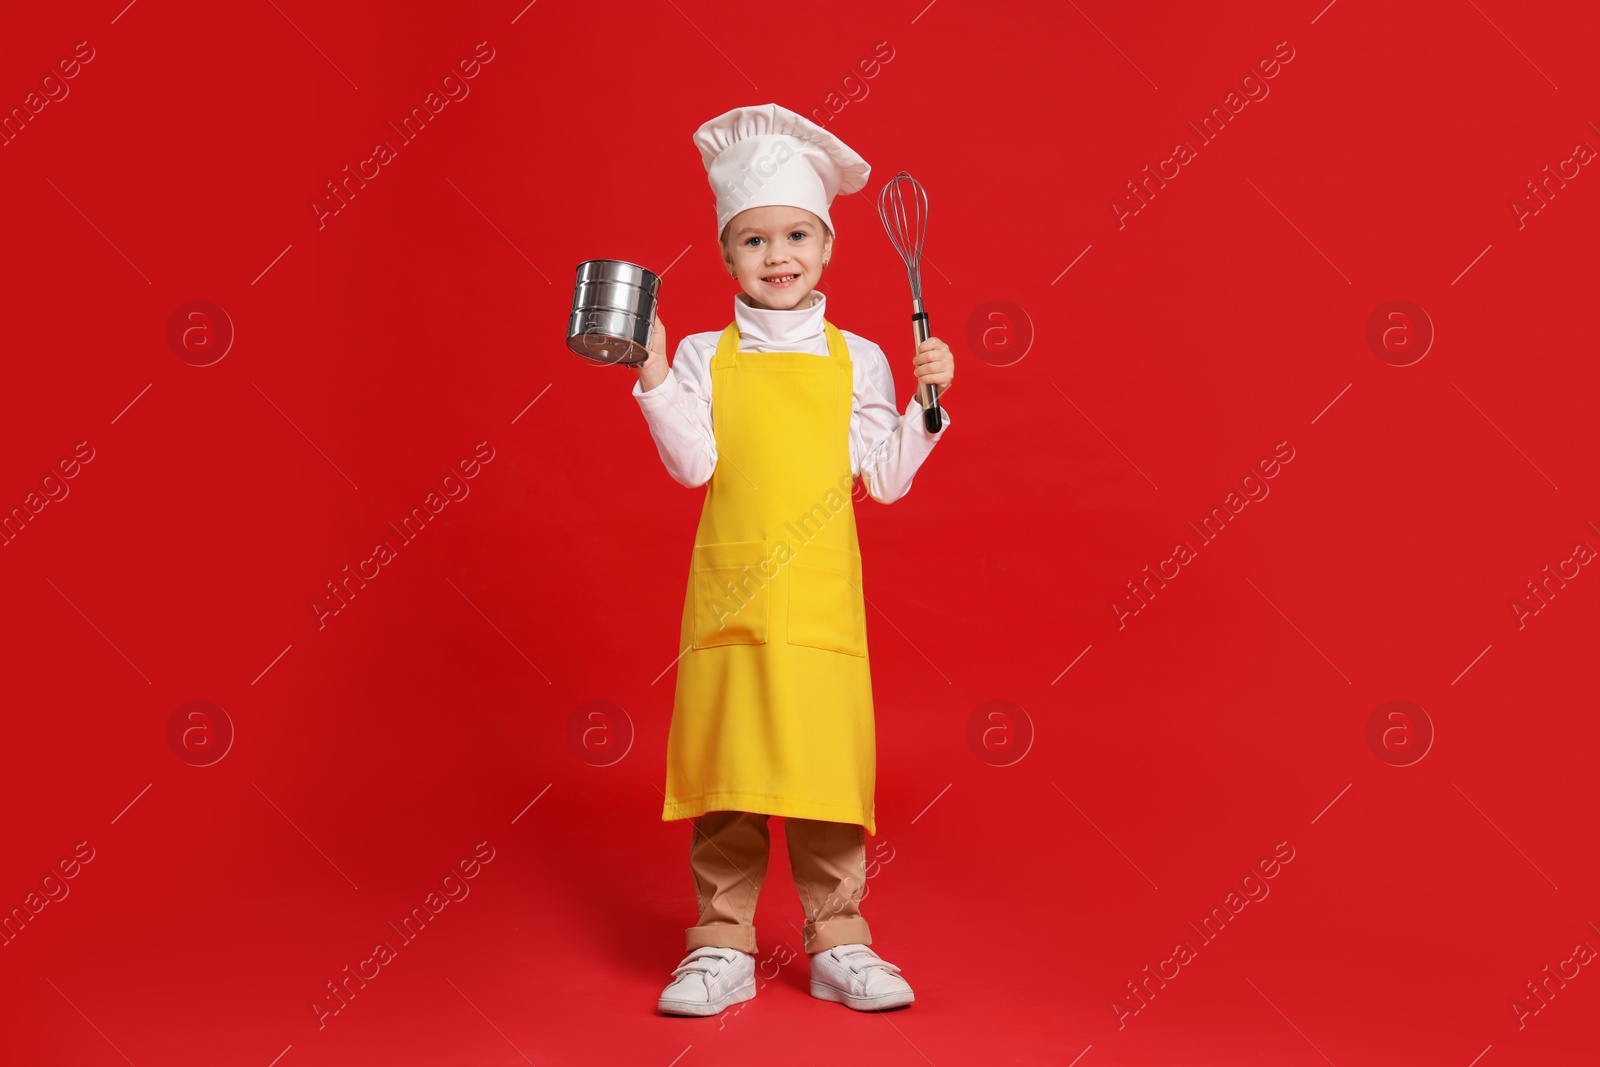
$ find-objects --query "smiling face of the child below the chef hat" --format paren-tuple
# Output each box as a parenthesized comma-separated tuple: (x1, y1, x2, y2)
(723, 205, 834, 310)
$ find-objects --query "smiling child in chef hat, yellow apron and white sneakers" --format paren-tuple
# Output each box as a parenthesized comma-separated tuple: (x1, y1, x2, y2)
(634, 104, 955, 1016)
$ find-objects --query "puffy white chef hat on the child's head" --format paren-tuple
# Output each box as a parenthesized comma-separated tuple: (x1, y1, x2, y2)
(694, 104, 872, 240)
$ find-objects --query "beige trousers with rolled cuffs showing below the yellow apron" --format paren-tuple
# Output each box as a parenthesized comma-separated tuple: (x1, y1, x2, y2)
(686, 811, 872, 955)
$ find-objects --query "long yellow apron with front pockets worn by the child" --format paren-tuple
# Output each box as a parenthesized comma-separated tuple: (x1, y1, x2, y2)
(661, 322, 877, 835)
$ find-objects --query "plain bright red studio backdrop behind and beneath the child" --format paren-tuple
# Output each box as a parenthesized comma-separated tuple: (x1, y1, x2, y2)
(0, 0, 1600, 1067)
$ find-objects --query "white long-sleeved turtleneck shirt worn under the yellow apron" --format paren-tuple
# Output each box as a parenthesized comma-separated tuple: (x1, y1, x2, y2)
(634, 291, 950, 504)
